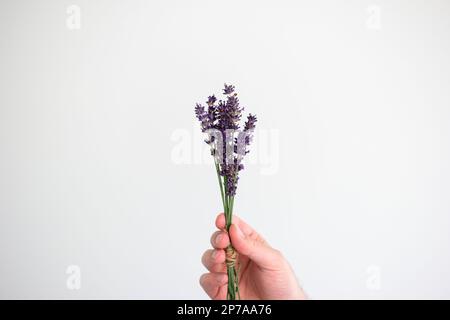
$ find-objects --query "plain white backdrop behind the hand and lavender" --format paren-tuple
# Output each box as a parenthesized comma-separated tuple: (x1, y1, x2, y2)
(0, 0, 450, 299)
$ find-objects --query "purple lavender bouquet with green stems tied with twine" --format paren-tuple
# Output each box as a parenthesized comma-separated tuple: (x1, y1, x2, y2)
(195, 84, 256, 300)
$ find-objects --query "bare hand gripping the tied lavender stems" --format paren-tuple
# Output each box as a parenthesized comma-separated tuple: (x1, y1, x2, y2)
(200, 213, 306, 300)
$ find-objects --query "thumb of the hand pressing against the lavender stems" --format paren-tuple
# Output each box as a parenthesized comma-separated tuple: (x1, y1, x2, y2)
(229, 224, 283, 269)
